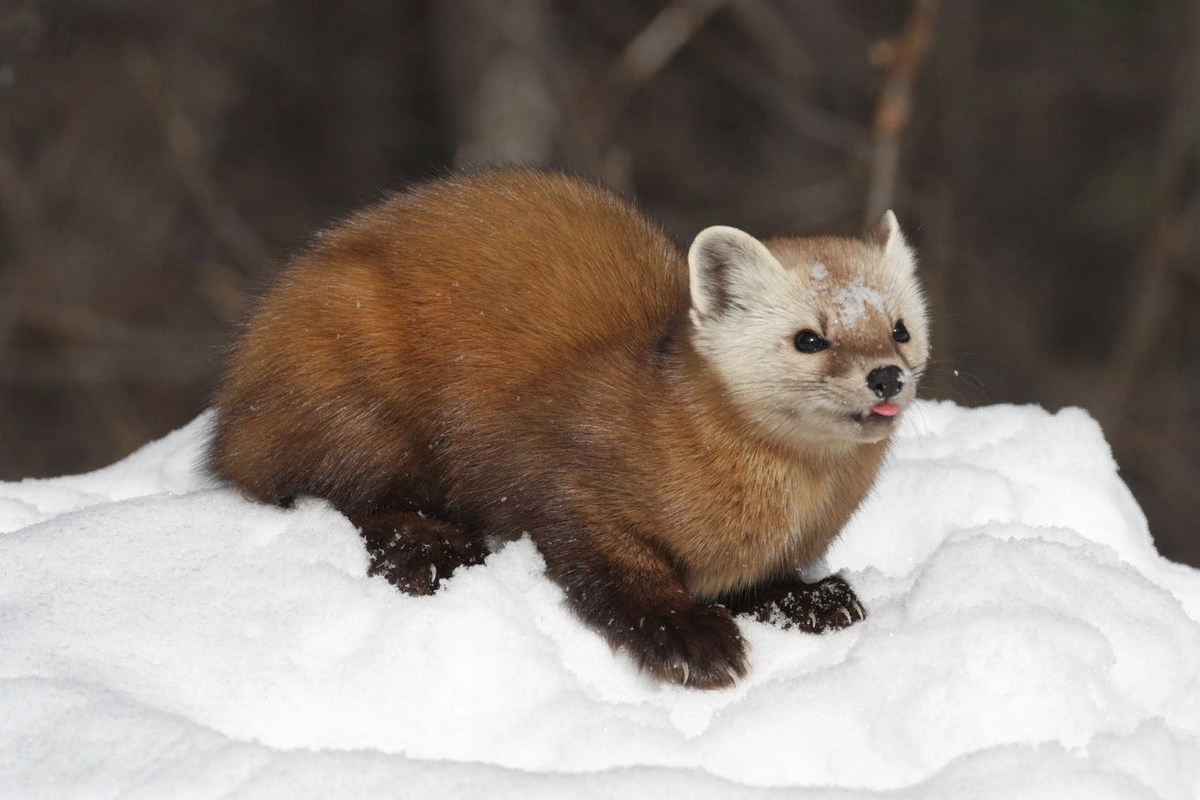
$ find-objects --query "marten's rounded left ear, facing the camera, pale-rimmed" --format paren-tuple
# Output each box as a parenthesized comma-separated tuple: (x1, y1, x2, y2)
(688, 225, 784, 318)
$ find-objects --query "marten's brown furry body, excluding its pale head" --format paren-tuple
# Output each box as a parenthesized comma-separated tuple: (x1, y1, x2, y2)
(210, 169, 902, 686)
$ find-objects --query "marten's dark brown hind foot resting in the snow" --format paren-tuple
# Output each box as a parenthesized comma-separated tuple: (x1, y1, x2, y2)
(350, 511, 487, 595)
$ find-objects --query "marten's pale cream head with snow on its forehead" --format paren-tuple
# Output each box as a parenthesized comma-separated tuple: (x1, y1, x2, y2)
(688, 211, 929, 443)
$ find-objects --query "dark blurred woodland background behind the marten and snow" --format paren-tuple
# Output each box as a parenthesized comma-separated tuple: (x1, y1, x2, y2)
(0, 0, 1200, 565)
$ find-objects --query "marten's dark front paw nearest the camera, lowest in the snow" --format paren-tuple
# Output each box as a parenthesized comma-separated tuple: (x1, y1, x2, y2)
(611, 603, 746, 688)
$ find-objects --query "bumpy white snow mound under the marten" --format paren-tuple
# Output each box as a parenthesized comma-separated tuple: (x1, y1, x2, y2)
(0, 402, 1200, 799)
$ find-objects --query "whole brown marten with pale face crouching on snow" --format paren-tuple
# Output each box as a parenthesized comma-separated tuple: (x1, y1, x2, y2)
(209, 168, 929, 688)
